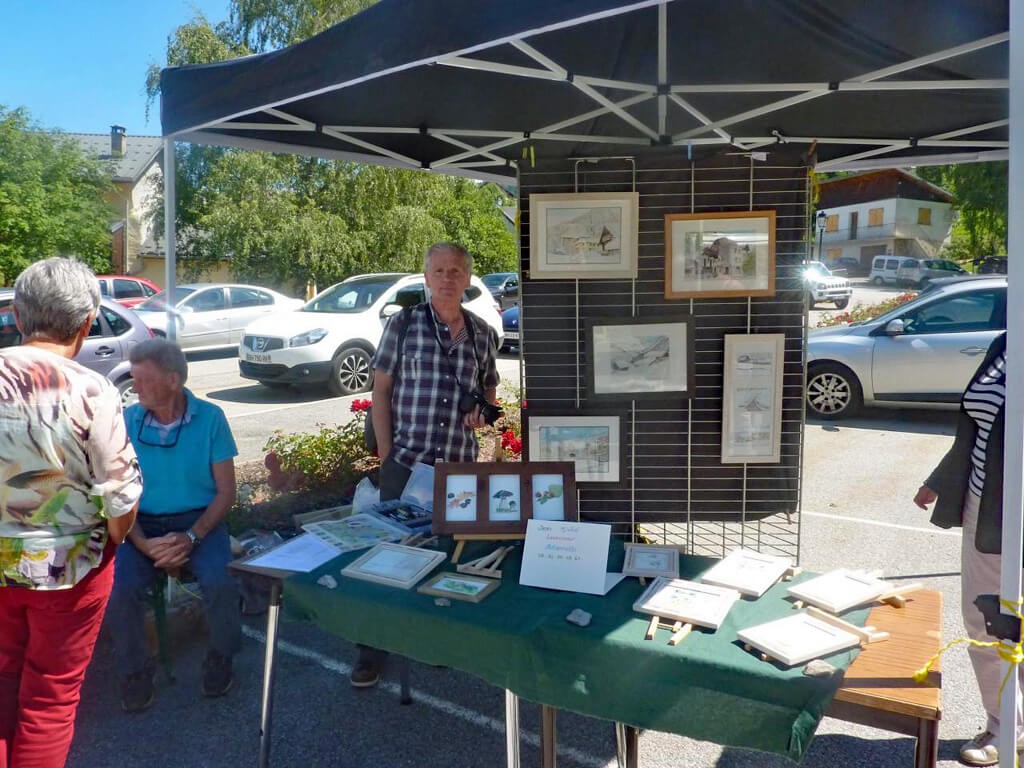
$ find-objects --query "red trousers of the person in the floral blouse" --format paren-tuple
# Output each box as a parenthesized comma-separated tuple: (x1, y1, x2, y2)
(0, 547, 114, 768)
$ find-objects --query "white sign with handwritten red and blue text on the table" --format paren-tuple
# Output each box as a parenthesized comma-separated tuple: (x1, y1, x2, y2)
(519, 519, 623, 595)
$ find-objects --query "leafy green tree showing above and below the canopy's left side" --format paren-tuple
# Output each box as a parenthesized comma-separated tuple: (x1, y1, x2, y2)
(146, 0, 517, 287)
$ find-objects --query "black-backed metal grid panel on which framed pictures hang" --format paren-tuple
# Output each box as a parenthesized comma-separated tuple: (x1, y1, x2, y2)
(519, 148, 809, 560)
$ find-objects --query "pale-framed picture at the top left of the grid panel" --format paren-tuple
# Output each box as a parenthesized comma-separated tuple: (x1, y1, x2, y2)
(529, 193, 640, 280)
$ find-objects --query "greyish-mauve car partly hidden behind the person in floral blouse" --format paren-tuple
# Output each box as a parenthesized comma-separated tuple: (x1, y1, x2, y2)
(0, 288, 153, 404)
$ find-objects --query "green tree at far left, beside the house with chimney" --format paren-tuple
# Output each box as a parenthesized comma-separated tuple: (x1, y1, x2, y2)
(0, 105, 115, 285)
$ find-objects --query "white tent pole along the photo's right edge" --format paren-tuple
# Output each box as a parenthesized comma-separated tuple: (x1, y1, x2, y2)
(998, 0, 1024, 768)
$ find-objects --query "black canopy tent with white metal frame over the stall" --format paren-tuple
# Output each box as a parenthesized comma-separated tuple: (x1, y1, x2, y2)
(161, 0, 1024, 760)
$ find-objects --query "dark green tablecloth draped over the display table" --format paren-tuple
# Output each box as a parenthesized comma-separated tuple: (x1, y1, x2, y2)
(284, 543, 867, 760)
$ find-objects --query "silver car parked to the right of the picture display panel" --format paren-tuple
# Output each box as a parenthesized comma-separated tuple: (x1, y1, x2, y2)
(806, 275, 1007, 419)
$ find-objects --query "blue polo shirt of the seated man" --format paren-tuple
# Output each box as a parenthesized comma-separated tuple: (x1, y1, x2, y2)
(125, 388, 239, 515)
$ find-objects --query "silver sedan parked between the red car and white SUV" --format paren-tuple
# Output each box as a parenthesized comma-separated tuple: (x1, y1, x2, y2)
(135, 283, 303, 350)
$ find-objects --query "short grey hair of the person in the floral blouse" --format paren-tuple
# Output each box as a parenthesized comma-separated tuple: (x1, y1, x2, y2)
(14, 256, 99, 341)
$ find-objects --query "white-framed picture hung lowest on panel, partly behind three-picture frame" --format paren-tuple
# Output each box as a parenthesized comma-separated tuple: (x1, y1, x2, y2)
(522, 408, 628, 487)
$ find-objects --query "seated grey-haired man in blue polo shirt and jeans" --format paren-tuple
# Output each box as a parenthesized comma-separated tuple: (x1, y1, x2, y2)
(109, 338, 242, 713)
